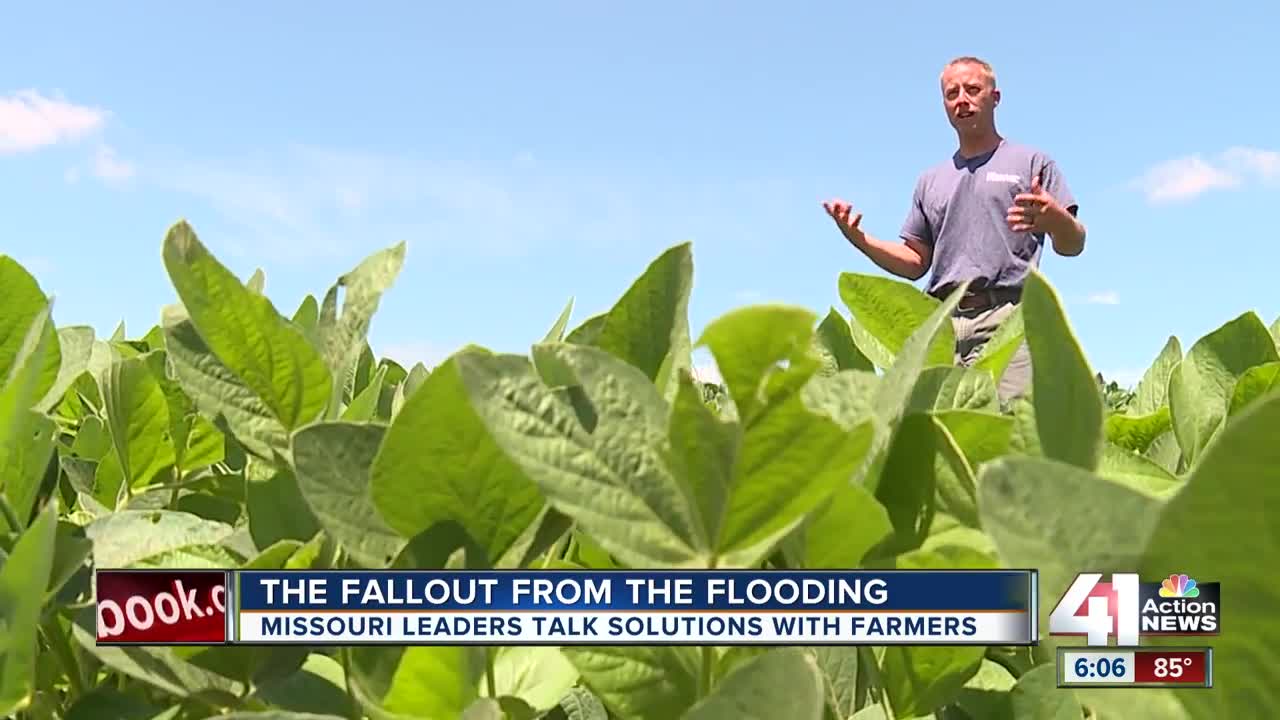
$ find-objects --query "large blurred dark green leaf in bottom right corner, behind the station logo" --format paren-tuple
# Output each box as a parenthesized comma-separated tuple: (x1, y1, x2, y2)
(1146, 395, 1280, 717)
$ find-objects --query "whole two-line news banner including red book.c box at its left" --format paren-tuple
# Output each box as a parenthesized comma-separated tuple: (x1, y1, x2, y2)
(96, 570, 1038, 646)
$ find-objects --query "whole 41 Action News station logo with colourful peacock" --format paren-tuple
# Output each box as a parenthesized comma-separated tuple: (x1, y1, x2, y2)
(1048, 573, 1221, 646)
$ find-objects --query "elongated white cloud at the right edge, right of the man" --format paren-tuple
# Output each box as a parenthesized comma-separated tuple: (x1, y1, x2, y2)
(1133, 146, 1280, 204)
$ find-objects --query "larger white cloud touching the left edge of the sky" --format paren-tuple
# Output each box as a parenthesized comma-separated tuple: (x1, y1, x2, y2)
(0, 90, 108, 155)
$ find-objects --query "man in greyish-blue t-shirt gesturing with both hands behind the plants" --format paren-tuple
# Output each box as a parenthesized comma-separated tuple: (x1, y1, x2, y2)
(823, 56, 1085, 404)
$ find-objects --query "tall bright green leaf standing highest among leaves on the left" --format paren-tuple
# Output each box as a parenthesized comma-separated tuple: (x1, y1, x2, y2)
(164, 222, 332, 430)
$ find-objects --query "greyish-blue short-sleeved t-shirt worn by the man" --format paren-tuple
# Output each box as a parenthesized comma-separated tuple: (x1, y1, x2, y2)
(900, 140, 1076, 297)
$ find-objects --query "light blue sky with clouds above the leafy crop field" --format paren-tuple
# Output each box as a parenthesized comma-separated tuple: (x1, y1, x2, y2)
(0, 1, 1280, 382)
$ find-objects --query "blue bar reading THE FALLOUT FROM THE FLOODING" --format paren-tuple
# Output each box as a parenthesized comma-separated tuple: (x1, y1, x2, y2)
(236, 570, 1034, 612)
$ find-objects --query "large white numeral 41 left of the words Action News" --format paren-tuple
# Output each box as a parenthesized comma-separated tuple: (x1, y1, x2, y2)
(1048, 573, 1139, 646)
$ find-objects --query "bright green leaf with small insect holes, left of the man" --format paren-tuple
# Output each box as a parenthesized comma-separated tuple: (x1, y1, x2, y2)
(695, 305, 815, 421)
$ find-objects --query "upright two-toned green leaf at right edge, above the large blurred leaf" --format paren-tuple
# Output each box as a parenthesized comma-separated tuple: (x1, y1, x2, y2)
(1169, 311, 1280, 462)
